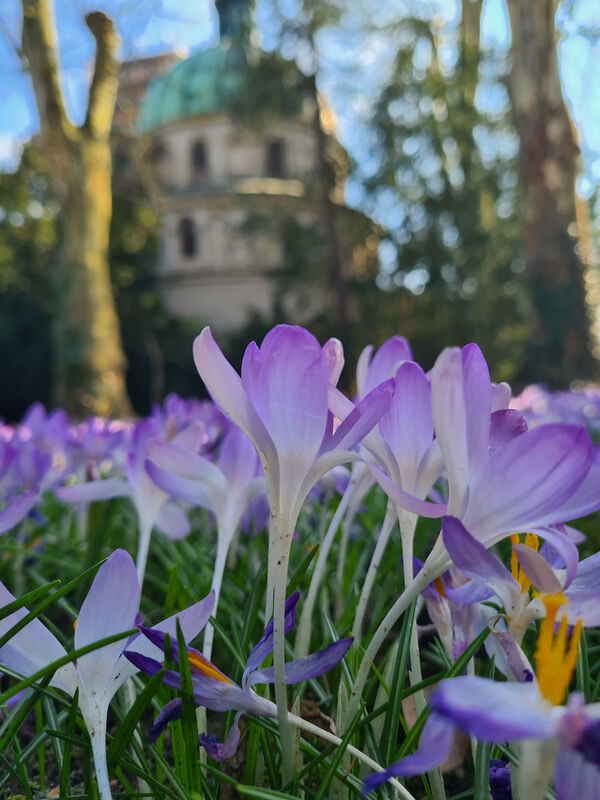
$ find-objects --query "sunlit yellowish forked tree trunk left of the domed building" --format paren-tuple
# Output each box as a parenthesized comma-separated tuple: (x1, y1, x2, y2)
(22, 0, 131, 417)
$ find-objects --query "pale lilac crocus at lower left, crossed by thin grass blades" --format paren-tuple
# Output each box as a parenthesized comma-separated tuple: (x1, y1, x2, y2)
(0, 550, 214, 800)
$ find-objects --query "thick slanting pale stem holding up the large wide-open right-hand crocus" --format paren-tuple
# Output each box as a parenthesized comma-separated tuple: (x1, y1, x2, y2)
(344, 536, 450, 729)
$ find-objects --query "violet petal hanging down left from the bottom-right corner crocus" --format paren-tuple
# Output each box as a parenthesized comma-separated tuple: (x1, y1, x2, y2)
(362, 713, 455, 795)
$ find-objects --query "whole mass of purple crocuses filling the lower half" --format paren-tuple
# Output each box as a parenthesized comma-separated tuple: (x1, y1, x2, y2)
(0, 325, 600, 800)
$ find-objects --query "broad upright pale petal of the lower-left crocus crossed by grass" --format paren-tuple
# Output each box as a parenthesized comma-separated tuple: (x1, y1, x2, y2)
(75, 550, 140, 699)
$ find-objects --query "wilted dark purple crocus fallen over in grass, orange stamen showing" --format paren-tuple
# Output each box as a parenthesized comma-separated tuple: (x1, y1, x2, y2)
(125, 592, 352, 761)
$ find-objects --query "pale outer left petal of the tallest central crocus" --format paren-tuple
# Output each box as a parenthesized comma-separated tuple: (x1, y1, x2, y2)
(194, 327, 276, 463)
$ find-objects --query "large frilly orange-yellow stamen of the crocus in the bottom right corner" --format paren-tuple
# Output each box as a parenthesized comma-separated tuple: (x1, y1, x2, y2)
(535, 592, 583, 706)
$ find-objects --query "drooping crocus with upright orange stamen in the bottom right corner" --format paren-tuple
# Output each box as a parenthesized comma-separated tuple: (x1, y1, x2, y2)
(363, 594, 600, 800)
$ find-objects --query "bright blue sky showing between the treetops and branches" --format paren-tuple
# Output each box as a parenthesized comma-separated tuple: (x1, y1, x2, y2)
(0, 0, 600, 190)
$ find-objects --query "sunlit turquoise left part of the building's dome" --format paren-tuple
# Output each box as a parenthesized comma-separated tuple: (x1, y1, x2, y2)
(137, 43, 248, 133)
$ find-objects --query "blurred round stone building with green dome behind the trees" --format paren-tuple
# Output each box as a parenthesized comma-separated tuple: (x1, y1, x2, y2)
(115, 0, 377, 333)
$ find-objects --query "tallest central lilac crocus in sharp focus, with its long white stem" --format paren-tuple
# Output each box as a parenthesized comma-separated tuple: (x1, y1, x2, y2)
(194, 325, 391, 777)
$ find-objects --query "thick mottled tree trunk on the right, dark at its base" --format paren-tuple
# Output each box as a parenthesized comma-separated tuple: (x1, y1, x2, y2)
(508, 0, 597, 386)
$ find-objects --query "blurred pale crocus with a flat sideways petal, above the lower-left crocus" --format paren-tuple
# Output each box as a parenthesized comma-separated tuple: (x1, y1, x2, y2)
(56, 418, 204, 583)
